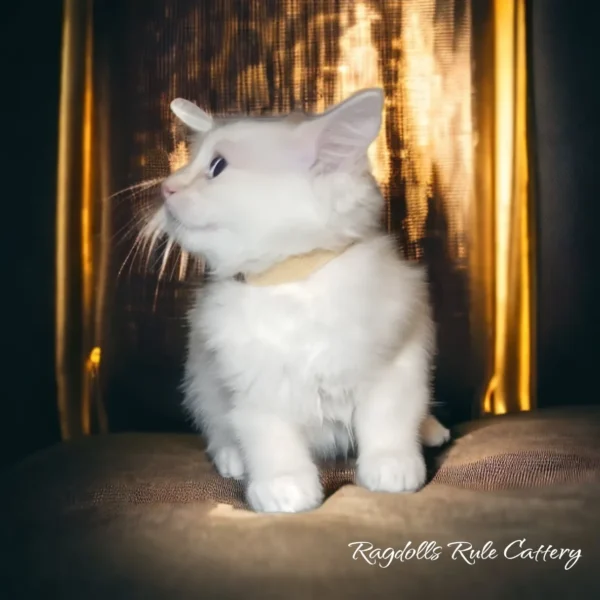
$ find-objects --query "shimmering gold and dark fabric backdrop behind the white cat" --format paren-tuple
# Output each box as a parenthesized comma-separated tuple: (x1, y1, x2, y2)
(57, 0, 531, 437)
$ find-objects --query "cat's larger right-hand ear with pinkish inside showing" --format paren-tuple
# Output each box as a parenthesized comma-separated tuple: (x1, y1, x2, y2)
(300, 88, 384, 170)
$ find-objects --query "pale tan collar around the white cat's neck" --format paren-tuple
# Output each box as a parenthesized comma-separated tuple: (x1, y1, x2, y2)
(234, 242, 354, 287)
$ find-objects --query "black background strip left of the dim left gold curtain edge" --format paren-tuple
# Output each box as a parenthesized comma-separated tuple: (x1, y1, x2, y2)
(0, 0, 62, 464)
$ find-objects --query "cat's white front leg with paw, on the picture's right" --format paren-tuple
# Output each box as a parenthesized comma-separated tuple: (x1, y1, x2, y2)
(354, 327, 430, 492)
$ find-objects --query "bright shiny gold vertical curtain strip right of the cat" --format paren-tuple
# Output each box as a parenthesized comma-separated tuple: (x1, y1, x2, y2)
(470, 0, 536, 414)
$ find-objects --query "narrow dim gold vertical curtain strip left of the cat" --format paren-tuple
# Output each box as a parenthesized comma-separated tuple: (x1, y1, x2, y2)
(55, 0, 108, 440)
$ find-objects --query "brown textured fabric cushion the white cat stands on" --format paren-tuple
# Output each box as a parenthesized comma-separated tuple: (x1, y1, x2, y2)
(0, 409, 600, 599)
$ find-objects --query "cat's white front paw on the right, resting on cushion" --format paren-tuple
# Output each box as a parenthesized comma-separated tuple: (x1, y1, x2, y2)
(356, 451, 427, 492)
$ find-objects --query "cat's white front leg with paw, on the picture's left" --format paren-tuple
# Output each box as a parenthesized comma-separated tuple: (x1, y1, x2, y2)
(232, 408, 323, 513)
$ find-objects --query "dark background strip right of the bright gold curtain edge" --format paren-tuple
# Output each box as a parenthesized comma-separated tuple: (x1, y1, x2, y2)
(529, 0, 600, 406)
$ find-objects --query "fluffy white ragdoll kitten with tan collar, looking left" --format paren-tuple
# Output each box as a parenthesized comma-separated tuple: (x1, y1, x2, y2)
(147, 89, 449, 512)
